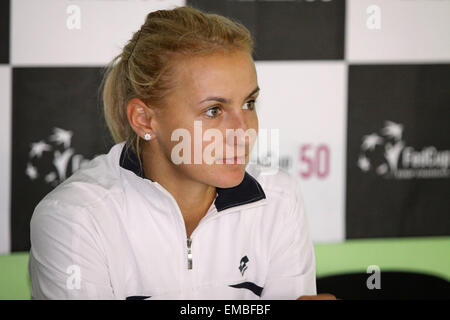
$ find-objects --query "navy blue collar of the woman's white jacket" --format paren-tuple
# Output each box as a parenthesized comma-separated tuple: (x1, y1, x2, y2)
(119, 143, 266, 211)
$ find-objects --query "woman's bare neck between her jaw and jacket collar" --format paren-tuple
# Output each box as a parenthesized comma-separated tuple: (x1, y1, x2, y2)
(142, 147, 216, 221)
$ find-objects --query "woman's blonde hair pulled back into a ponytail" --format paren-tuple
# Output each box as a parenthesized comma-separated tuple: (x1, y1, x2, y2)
(100, 6, 254, 168)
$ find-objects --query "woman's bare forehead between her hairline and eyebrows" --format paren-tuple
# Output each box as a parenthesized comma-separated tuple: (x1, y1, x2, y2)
(169, 51, 257, 102)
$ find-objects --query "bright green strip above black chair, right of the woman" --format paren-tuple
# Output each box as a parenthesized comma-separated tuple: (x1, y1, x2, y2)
(314, 237, 450, 281)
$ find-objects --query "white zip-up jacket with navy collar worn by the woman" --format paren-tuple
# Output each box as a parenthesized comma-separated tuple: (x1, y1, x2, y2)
(28, 142, 316, 299)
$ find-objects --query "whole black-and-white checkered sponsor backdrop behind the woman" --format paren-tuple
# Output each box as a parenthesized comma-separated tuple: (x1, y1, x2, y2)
(0, 0, 450, 254)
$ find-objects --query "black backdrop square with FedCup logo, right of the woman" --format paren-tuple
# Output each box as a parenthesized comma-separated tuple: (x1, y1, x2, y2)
(346, 64, 450, 238)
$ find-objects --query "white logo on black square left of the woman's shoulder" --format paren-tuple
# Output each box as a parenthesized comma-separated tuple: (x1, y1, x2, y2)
(25, 127, 93, 187)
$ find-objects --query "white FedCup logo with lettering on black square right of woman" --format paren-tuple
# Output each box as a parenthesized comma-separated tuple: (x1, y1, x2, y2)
(357, 121, 450, 179)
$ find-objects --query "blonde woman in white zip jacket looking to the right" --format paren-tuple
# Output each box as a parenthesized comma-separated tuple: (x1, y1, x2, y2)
(29, 7, 330, 299)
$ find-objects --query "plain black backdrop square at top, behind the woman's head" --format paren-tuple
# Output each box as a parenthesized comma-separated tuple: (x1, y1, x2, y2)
(186, 0, 345, 60)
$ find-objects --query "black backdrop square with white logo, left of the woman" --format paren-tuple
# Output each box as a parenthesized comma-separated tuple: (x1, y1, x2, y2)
(11, 67, 112, 251)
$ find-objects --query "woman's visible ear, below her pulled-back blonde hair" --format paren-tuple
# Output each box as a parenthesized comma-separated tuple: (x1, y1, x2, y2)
(126, 98, 155, 138)
